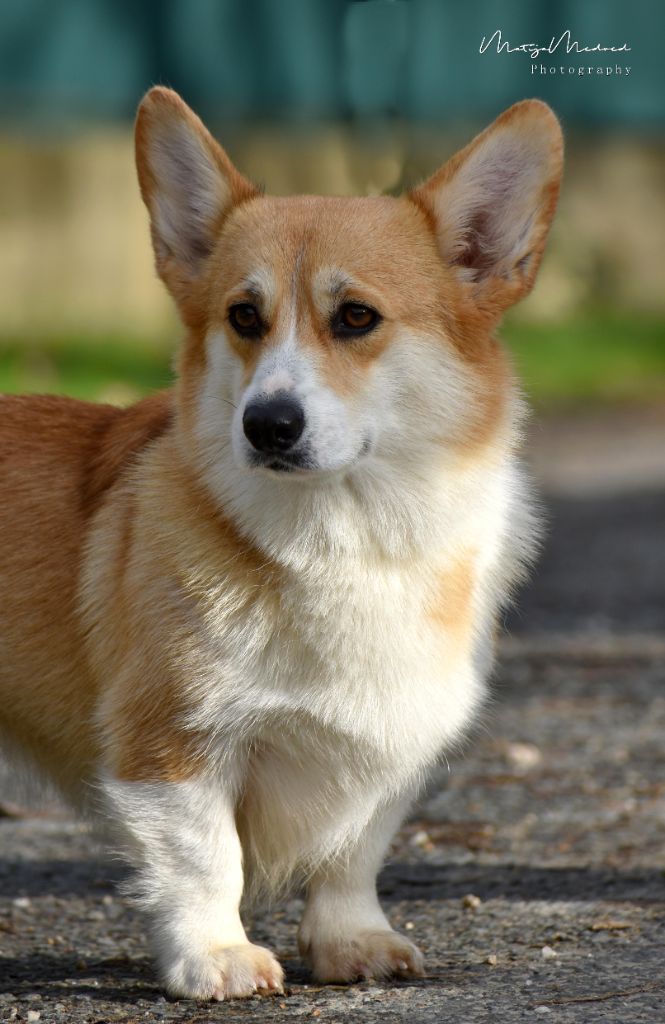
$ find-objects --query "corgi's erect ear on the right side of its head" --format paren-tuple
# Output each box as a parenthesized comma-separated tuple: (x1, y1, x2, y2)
(410, 99, 564, 311)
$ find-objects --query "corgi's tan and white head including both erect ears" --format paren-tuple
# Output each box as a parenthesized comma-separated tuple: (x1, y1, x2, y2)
(136, 88, 563, 480)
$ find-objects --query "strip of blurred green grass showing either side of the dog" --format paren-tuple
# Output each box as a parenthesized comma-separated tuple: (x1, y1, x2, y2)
(0, 312, 665, 407)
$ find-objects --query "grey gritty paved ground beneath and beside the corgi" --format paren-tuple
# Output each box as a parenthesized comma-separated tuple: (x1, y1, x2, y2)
(0, 409, 665, 1024)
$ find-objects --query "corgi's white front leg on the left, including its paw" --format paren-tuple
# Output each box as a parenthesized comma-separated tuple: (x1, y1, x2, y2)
(103, 779, 283, 999)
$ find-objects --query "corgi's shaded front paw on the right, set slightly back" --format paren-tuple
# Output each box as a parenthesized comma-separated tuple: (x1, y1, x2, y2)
(305, 929, 424, 981)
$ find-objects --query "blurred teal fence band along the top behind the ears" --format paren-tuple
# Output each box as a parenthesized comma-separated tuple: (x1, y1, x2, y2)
(0, 0, 665, 130)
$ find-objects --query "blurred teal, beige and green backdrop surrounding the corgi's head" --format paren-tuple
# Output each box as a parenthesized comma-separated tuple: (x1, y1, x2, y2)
(0, 0, 665, 403)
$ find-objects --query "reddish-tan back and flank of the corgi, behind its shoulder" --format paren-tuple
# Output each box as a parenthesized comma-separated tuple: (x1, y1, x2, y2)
(0, 395, 170, 793)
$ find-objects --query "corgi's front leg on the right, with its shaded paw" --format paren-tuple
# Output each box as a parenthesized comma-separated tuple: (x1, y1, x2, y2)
(298, 803, 423, 981)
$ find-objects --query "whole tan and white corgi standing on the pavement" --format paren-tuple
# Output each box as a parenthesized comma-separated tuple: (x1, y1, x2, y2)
(0, 87, 563, 999)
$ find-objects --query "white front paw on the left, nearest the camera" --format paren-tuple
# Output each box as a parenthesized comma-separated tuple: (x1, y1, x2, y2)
(166, 942, 284, 999)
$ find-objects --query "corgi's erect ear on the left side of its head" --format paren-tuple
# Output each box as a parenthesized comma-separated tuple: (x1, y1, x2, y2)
(135, 86, 258, 321)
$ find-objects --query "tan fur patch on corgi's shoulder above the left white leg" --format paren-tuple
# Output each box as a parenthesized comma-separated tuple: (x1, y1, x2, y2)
(84, 434, 279, 782)
